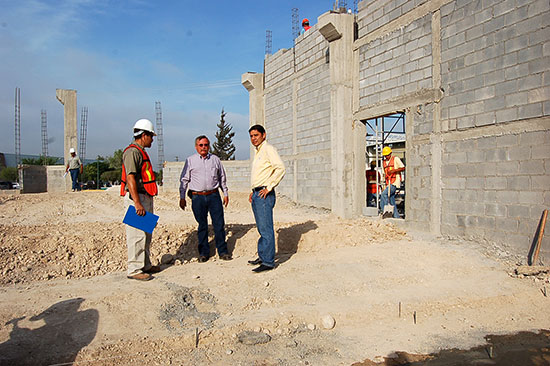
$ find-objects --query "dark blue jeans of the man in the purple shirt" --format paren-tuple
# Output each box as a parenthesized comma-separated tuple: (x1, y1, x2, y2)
(191, 191, 228, 257)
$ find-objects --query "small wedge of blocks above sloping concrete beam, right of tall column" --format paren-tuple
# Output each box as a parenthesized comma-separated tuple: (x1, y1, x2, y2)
(357, 0, 434, 38)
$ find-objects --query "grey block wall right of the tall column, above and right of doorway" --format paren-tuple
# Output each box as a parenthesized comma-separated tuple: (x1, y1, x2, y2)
(357, 0, 550, 260)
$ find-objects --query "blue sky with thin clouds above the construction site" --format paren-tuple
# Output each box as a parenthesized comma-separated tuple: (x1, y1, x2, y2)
(0, 0, 344, 166)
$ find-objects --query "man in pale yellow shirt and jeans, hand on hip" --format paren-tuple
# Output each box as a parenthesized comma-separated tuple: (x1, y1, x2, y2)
(248, 125, 285, 273)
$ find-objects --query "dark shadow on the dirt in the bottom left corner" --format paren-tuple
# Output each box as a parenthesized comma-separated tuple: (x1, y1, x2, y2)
(0, 298, 99, 365)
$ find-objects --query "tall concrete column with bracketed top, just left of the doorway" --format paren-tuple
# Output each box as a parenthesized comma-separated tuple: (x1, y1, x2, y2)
(318, 12, 358, 218)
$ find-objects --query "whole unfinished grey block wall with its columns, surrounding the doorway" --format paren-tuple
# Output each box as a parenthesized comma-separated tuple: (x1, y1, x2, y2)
(239, 0, 550, 255)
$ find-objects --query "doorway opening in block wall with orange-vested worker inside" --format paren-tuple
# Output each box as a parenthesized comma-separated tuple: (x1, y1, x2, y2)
(362, 111, 406, 219)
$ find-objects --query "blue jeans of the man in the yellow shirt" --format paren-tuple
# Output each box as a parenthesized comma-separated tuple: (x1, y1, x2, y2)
(252, 190, 275, 267)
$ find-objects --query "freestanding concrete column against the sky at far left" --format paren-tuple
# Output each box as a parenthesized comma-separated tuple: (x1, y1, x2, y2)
(55, 89, 79, 191)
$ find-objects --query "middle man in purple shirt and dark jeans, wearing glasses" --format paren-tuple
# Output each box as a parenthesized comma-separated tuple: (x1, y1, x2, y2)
(180, 135, 231, 263)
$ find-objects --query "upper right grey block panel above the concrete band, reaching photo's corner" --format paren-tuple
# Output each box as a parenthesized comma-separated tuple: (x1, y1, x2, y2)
(441, 0, 550, 130)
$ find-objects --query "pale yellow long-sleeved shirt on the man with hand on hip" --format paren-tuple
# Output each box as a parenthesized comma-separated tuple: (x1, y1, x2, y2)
(250, 141, 285, 191)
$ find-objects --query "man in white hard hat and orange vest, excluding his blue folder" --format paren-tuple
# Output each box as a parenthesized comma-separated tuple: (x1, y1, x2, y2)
(120, 119, 160, 281)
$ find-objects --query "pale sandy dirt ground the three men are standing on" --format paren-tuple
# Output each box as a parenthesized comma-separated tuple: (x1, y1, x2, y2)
(0, 188, 550, 366)
